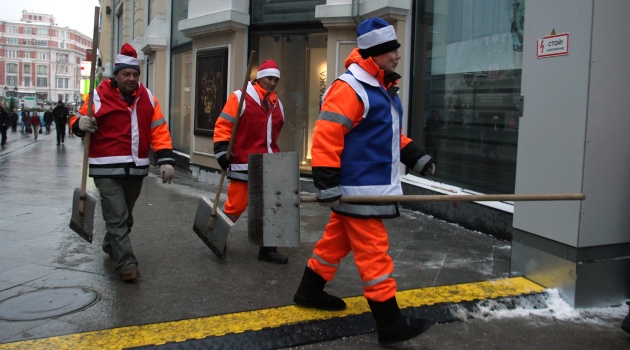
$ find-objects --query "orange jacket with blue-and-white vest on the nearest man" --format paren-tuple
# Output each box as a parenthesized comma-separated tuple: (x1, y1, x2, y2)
(311, 49, 432, 218)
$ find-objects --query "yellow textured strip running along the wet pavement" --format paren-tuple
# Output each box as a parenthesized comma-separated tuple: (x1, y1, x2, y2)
(0, 277, 544, 350)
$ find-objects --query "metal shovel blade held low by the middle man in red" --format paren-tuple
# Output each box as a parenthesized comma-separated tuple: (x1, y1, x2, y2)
(193, 197, 234, 259)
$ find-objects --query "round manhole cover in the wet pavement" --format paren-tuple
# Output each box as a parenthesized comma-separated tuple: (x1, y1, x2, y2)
(0, 288, 99, 321)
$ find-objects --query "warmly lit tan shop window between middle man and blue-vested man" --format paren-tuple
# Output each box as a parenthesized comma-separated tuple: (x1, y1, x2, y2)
(251, 32, 328, 172)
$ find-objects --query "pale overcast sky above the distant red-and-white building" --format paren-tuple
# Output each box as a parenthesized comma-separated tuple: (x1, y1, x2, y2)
(0, 0, 103, 38)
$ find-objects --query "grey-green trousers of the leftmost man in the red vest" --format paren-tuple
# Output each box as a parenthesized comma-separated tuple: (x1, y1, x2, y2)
(94, 176, 144, 271)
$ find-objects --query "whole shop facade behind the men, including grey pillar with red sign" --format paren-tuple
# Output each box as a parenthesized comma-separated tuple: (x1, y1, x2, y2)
(100, 0, 630, 306)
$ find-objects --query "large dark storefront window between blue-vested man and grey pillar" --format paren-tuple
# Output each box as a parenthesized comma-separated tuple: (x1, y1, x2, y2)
(409, 0, 525, 193)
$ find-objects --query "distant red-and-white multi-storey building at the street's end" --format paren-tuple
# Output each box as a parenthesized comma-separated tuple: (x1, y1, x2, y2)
(0, 10, 92, 108)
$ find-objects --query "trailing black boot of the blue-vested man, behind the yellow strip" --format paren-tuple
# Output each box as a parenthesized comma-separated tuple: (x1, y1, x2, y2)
(293, 266, 346, 311)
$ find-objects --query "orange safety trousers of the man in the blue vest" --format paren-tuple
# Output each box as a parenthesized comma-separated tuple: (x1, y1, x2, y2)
(308, 212, 396, 302)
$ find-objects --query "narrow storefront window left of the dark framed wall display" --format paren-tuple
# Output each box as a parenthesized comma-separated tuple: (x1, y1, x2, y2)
(169, 47, 193, 154)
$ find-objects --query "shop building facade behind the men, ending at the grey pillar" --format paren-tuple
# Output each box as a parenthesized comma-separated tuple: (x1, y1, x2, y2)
(100, 0, 524, 193)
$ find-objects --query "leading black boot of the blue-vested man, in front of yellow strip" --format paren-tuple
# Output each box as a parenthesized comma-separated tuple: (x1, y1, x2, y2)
(368, 297, 433, 344)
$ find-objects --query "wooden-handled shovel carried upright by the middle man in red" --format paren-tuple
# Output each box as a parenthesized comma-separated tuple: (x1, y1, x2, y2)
(193, 51, 256, 261)
